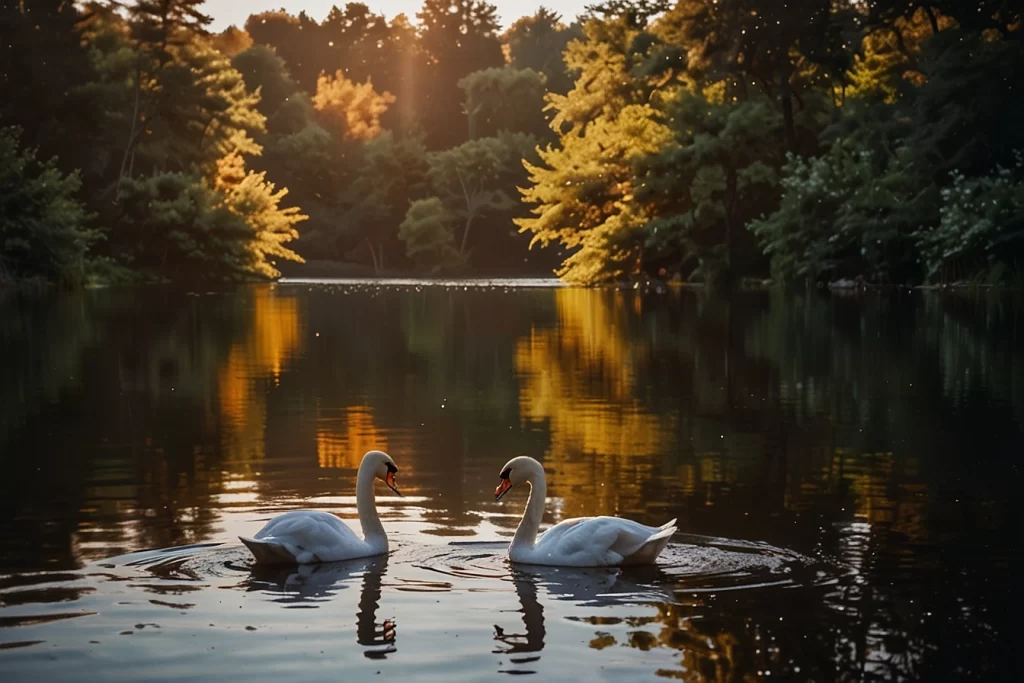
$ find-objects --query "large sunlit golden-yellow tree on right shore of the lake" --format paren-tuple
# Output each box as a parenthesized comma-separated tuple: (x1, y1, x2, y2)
(515, 19, 671, 284)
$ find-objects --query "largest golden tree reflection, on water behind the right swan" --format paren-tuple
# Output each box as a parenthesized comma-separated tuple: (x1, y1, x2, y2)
(514, 288, 671, 516)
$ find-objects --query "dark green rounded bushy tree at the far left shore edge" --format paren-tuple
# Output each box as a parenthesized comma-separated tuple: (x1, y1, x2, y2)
(0, 126, 100, 285)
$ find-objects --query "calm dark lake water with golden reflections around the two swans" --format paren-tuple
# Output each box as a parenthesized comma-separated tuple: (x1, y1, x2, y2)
(0, 283, 1024, 683)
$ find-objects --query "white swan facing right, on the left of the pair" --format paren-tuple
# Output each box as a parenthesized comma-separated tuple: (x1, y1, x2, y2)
(239, 451, 401, 564)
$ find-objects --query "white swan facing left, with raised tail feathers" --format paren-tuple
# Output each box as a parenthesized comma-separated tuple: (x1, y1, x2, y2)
(495, 456, 676, 567)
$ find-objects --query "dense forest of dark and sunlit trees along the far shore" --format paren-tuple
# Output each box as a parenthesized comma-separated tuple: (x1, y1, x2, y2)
(0, 0, 1024, 286)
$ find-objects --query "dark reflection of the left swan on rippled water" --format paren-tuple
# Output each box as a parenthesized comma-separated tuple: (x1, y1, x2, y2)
(247, 556, 397, 659)
